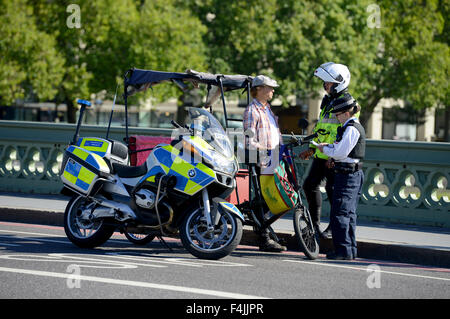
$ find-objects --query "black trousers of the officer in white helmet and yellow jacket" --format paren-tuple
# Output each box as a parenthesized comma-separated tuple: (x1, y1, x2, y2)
(303, 158, 334, 226)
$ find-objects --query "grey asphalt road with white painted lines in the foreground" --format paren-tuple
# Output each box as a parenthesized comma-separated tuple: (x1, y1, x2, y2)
(0, 222, 450, 304)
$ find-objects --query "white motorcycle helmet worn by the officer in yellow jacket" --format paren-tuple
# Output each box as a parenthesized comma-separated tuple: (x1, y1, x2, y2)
(314, 62, 350, 93)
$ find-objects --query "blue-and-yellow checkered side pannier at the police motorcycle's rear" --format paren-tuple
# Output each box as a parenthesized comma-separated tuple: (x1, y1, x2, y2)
(61, 146, 109, 195)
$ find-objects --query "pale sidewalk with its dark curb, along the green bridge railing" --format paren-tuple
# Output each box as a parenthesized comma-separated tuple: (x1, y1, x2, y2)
(0, 192, 450, 268)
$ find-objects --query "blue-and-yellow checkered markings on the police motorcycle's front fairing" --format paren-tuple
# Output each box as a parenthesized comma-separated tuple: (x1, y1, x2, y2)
(144, 145, 216, 195)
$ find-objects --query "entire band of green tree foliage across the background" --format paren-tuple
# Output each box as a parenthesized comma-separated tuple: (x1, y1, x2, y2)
(0, 0, 450, 127)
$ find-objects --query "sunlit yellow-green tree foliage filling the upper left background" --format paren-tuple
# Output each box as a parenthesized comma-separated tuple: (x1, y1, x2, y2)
(0, 0, 206, 122)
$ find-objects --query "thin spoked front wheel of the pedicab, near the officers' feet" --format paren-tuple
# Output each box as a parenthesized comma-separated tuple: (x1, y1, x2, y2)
(294, 206, 320, 259)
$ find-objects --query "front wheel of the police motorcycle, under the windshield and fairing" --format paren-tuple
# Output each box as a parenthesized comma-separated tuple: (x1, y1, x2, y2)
(180, 207, 242, 260)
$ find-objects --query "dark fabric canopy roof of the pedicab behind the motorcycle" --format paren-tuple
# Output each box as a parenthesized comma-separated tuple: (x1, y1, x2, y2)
(125, 68, 253, 96)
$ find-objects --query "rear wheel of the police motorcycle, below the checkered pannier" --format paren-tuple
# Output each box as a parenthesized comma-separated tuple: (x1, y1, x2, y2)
(64, 196, 115, 248)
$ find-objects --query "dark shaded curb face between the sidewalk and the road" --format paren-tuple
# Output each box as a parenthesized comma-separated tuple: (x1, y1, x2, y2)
(0, 207, 450, 268)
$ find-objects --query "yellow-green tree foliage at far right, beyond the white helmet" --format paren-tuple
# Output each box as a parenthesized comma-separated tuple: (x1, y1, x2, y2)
(365, 0, 450, 124)
